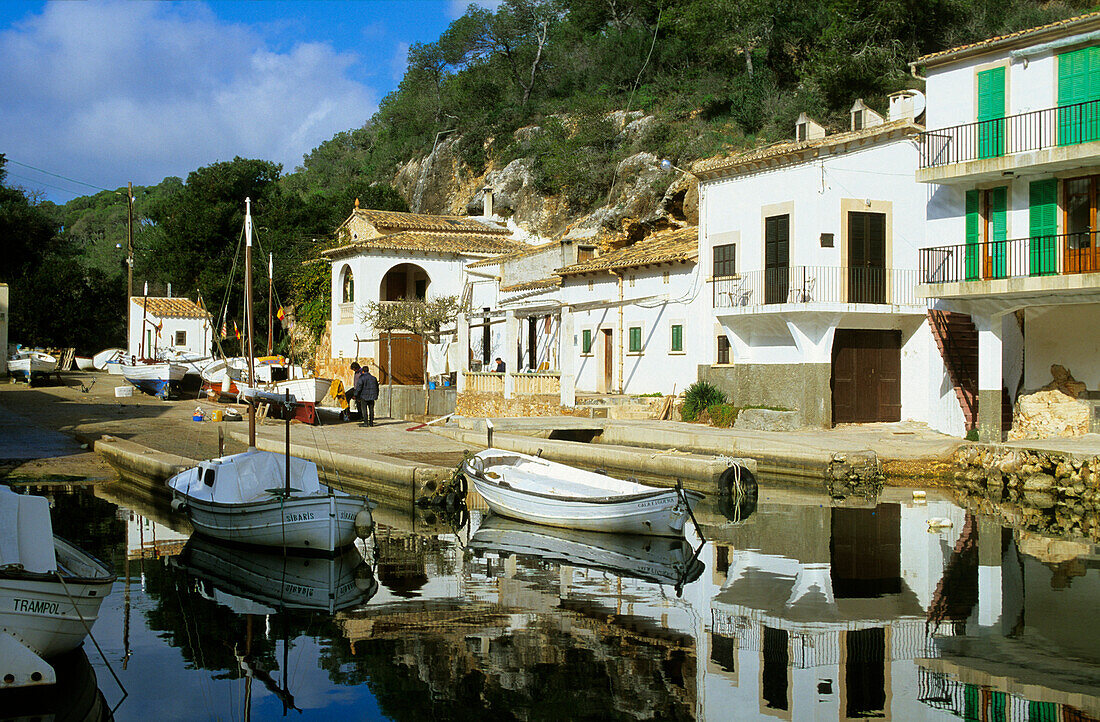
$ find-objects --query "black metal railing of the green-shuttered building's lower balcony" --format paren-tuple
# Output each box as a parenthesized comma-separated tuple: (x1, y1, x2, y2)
(917, 230, 1100, 283)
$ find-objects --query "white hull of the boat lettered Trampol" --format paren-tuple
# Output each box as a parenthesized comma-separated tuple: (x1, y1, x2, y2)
(0, 539, 114, 658)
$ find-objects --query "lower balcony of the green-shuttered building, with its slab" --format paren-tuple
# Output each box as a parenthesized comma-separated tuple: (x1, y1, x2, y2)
(919, 231, 1100, 298)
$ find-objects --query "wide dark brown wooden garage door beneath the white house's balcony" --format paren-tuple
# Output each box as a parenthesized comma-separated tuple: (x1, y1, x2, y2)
(833, 328, 901, 424)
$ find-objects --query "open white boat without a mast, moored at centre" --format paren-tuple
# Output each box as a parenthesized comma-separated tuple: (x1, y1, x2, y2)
(462, 449, 703, 536)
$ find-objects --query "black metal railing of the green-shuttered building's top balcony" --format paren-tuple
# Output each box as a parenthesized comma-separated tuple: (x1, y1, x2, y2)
(919, 100, 1100, 168)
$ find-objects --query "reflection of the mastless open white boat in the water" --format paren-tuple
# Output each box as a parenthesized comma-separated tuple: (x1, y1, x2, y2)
(469, 516, 704, 594)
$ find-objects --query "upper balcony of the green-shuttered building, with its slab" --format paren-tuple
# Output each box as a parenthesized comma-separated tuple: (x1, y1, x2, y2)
(916, 100, 1100, 183)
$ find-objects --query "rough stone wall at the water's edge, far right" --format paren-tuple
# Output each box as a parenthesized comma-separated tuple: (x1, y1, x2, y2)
(955, 446, 1100, 542)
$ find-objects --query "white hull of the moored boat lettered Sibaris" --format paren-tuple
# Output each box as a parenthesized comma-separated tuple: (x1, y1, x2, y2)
(173, 491, 369, 553)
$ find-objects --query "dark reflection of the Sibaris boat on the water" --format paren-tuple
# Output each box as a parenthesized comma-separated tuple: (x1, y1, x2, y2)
(172, 534, 378, 614)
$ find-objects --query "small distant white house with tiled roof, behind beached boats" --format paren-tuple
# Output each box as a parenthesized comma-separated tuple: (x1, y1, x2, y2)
(127, 296, 213, 359)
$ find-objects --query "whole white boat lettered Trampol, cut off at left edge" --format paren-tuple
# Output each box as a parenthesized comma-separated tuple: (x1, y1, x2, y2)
(0, 486, 114, 688)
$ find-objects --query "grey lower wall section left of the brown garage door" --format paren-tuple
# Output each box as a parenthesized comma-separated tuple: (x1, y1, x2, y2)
(699, 363, 833, 428)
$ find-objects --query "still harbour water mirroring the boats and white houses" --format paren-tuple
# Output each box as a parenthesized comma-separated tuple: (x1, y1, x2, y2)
(19, 482, 1100, 722)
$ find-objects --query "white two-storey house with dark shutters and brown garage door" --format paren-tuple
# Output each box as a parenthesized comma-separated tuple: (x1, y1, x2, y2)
(695, 104, 965, 435)
